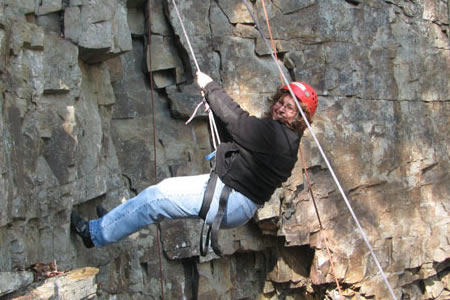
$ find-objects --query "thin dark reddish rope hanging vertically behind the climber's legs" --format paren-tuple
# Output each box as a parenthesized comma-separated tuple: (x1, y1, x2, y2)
(147, 0, 164, 300)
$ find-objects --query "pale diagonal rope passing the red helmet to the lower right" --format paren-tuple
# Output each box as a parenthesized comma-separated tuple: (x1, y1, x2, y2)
(243, 0, 397, 300)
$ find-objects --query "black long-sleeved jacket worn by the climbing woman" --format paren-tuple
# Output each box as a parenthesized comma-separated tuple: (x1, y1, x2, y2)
(205, 82, 301, 204)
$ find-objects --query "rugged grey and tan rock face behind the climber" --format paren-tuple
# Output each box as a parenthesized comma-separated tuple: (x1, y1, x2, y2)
(0, 0, 450, 299)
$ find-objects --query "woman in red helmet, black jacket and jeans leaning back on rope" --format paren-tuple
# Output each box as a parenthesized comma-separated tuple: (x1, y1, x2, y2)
(71, 71, 317, 248)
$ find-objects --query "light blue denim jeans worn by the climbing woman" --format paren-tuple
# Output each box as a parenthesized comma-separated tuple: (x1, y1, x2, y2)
(89, 174, 260, 248)
